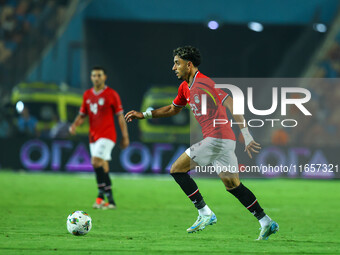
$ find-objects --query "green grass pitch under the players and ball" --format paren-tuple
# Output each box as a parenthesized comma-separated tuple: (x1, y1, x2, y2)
(0, 171, 340, 255)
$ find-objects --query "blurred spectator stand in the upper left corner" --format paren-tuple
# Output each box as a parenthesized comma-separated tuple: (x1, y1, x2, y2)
(0, 0, 70, 84)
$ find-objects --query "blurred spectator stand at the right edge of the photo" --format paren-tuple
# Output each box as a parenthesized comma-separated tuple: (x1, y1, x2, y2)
(271, 11, 340, 146)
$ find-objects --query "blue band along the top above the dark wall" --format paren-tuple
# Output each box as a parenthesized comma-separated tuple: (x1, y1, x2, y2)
(83, 0, 339, 24)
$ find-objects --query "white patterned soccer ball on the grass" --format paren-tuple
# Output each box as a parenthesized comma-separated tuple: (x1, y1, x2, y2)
(66, 211, 92, 236)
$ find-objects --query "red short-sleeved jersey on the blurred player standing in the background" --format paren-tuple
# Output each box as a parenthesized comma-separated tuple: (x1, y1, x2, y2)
(80, 86, 123, 143)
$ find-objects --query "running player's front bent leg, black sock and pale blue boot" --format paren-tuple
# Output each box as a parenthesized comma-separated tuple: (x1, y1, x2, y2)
(170, 146, 217, 233)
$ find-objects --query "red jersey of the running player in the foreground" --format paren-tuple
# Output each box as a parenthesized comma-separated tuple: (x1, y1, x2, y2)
(172, 71, 235, 140)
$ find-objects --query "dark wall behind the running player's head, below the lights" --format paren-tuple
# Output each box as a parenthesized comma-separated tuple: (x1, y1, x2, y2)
(86, 20, 322, 107)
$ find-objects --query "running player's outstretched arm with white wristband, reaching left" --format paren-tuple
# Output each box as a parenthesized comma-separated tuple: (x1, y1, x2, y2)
(125, 104, 182, 122)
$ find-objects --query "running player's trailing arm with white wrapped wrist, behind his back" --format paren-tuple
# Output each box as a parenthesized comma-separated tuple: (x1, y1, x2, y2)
(223, 96, 261, 158)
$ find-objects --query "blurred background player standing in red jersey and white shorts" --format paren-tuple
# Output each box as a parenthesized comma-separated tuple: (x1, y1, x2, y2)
(70, 67, 129, 209)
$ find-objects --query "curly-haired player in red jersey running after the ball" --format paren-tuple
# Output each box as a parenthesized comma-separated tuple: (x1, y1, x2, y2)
(125, 46, 279, 240)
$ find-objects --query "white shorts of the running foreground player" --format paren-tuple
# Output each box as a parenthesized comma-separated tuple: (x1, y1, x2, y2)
(185, 137, 238, 174)
